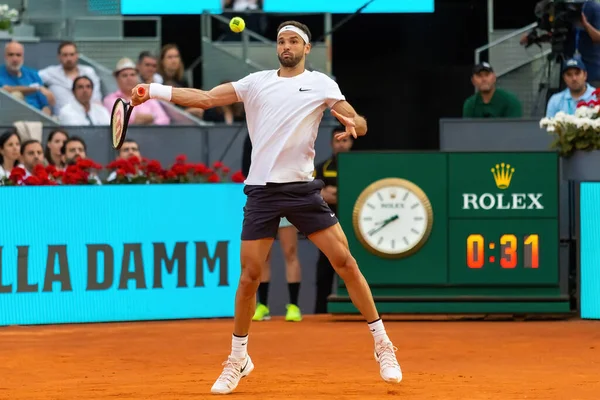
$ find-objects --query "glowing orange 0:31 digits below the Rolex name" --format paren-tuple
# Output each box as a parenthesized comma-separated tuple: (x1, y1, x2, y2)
(467, 234, 540, 269)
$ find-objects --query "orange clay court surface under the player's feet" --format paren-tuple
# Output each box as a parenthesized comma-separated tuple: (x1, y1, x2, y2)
(0, 317, 600, 400)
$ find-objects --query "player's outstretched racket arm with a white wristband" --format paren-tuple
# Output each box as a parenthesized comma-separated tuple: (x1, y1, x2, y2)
(131, 83, 238, 110)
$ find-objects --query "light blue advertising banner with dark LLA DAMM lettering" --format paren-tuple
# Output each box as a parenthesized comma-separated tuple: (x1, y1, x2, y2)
(0, 183, 245, 325)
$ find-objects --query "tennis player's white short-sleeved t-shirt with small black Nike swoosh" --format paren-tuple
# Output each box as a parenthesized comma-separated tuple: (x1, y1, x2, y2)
(232, 70, 346, 185)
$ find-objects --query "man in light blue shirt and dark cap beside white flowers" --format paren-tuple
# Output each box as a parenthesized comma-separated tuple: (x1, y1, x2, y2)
(546, 58, 596, 118)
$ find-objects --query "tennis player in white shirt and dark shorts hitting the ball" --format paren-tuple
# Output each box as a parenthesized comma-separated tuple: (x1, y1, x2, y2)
(131, 21, 402, 394)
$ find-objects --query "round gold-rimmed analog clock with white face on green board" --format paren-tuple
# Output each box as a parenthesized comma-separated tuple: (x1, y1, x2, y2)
(352, 178, 433, 258)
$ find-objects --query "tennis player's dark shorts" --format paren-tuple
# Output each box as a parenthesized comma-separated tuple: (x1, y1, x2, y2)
(242, 179, 338, 240)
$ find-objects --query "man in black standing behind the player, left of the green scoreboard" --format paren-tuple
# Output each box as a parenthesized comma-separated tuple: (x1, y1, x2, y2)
(314, 126, 354, 314)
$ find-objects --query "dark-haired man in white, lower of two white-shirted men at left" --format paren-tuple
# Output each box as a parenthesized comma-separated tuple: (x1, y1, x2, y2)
(58, 76, 110, 126)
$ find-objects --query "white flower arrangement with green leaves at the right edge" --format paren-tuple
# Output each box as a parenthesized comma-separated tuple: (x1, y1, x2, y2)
(540, 90, 600, 157)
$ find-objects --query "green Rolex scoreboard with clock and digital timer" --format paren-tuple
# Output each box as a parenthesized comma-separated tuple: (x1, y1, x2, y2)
(328, 152, 569, 313)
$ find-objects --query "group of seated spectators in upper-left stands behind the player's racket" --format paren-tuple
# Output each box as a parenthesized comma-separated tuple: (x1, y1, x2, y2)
(0, 41, 245, 126)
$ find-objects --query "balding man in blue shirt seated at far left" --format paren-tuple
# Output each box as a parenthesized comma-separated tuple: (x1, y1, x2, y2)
(0, 41, 55, 115)
